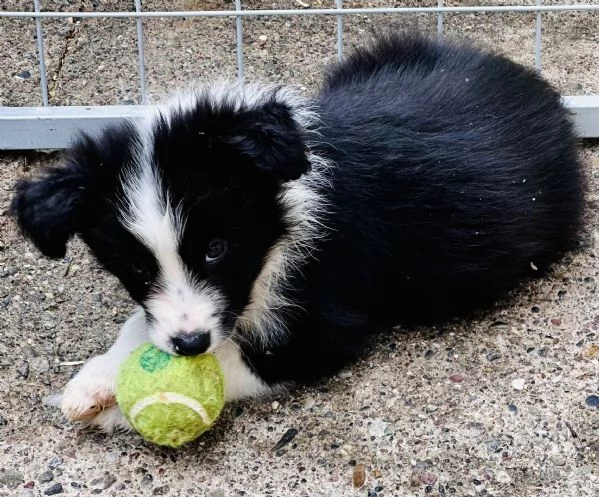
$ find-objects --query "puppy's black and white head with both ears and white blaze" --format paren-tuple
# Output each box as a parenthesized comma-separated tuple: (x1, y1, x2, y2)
(13, 87, 309, 355)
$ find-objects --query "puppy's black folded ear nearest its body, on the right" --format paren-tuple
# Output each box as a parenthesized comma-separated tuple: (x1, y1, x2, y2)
(228, 101, 310, 181)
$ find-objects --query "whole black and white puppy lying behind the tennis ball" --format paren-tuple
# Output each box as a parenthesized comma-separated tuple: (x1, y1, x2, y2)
(13, 34, 584, 430)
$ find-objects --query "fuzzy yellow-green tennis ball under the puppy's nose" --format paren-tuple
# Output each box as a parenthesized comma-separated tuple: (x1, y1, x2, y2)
(116, 343, 225, 447)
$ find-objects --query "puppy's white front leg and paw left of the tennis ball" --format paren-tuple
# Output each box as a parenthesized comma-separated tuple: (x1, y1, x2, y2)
(59, 309, 148, 432)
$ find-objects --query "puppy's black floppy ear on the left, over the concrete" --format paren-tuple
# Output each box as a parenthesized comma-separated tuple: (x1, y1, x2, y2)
(11, 166, 85, 257)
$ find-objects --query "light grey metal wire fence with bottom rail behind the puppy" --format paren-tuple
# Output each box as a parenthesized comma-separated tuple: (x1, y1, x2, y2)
(0, 0, 599, 149)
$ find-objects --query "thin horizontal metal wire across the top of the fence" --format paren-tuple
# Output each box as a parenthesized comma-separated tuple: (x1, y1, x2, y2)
(0, 4, 599, 19)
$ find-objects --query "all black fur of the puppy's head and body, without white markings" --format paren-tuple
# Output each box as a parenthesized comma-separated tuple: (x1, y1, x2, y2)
(13, 35, 584, 390)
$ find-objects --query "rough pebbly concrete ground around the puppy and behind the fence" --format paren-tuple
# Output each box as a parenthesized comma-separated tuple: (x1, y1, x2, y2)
(0, 0, 599, 497)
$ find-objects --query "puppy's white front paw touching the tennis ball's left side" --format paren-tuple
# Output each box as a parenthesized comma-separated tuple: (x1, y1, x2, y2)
(54, 354, 129, 432)
